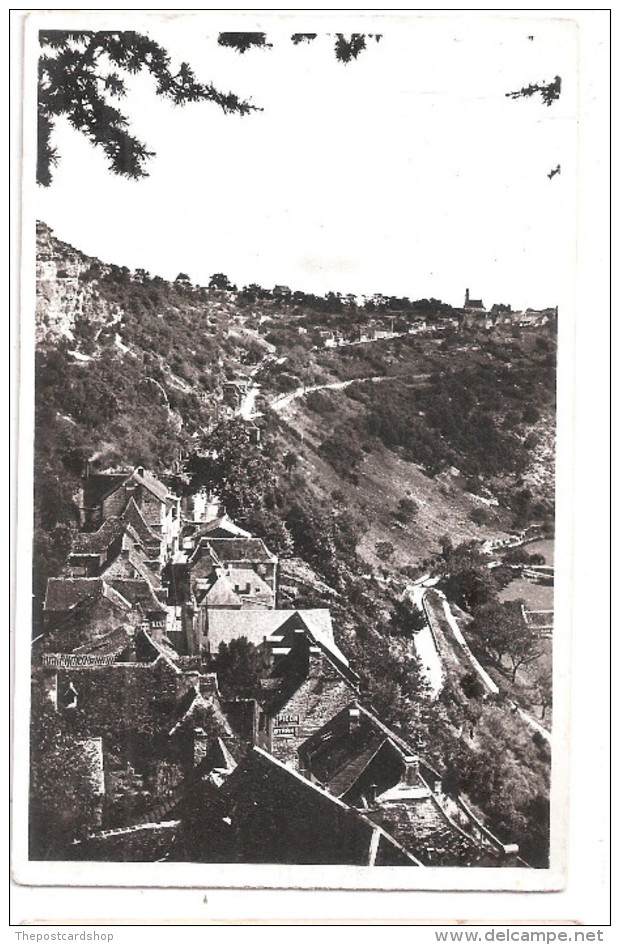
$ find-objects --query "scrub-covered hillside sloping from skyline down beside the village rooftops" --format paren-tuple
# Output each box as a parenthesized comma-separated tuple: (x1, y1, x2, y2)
(34, 224, 555, 863)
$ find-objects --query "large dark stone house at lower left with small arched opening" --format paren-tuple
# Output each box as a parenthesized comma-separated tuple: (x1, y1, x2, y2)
(36, 627, 257, 844)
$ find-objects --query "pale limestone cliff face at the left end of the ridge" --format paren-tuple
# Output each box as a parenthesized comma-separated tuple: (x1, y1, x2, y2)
(36, 223, 121, 344)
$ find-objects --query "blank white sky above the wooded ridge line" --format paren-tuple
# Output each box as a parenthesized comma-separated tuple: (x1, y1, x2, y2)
(33, 13, 578, 307)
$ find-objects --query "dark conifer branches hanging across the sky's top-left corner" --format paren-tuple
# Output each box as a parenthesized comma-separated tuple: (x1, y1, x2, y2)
(37, 30, 257, 187)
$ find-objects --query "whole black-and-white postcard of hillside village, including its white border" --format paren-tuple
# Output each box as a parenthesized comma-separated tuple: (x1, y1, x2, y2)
(9, 11, 612, 916)
